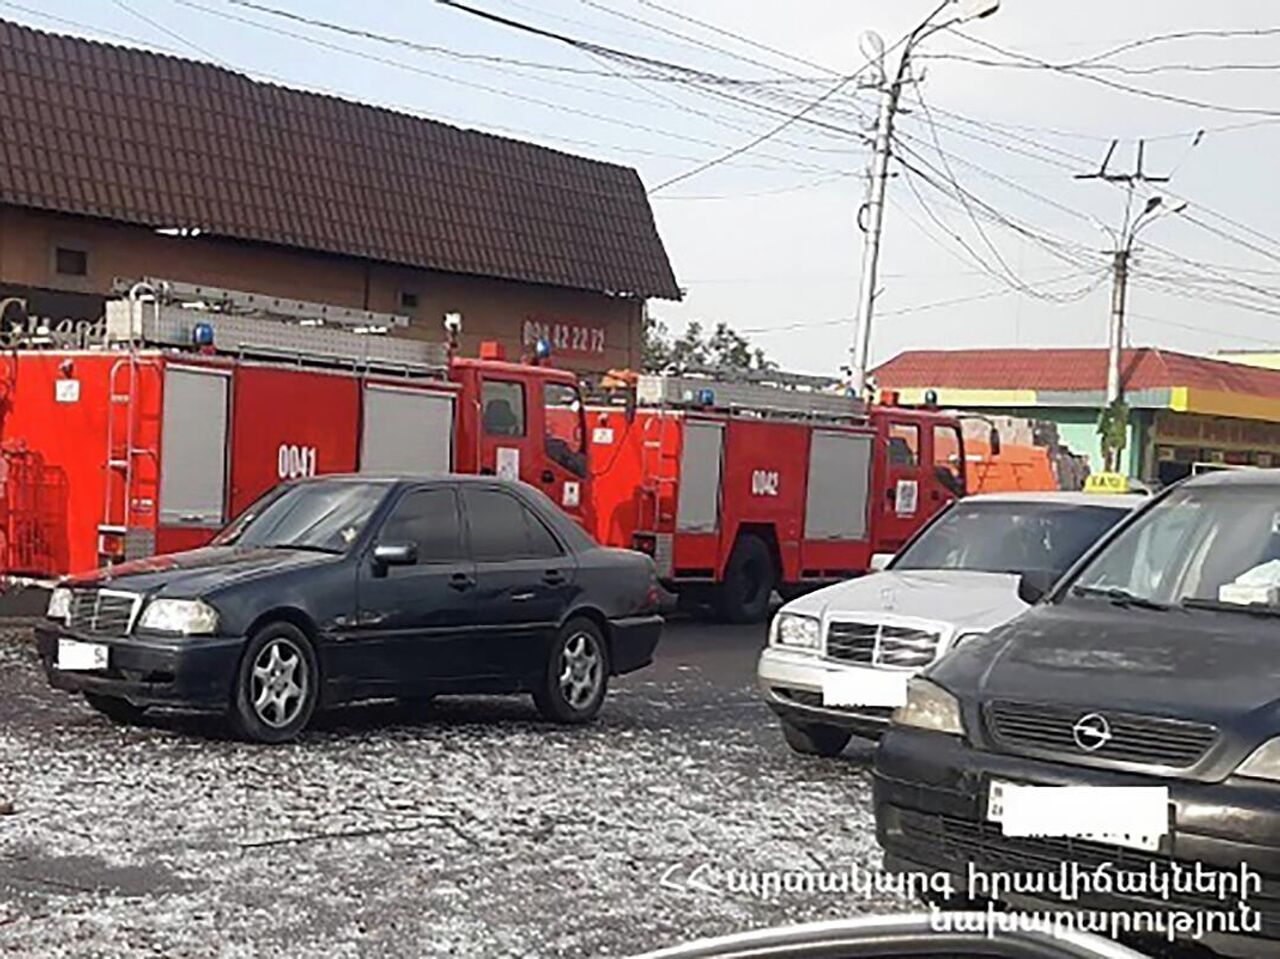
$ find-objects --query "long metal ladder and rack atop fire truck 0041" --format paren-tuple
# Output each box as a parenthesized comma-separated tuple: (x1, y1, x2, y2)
(106, 278, 448, 376)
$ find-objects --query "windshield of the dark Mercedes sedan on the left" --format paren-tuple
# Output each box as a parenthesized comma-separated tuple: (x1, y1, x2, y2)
(214, 481, 387, 553)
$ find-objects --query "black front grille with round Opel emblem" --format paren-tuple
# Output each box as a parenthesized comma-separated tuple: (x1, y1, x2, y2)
(987, 702, 1217, 770)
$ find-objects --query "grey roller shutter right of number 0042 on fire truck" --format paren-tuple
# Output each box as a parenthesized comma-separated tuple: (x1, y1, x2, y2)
(804, 430, 873, 540)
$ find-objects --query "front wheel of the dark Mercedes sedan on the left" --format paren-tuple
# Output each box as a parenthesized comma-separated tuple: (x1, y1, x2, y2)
(230, 622, 320, 743)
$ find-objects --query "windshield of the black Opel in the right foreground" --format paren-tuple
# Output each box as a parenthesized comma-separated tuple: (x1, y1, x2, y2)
(1073, 485, 1280, 607)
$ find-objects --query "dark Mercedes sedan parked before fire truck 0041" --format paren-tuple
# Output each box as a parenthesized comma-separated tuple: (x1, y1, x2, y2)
(36, 476, 662, 743)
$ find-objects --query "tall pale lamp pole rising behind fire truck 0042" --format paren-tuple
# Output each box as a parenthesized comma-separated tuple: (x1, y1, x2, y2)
(850, 0, 1000, 397)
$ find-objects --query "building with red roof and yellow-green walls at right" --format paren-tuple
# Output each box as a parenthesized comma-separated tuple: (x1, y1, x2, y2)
(876, 347, 1280, 483)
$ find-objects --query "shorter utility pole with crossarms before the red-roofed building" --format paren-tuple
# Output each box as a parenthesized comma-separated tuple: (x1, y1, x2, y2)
(1075, 140, 1187, 472)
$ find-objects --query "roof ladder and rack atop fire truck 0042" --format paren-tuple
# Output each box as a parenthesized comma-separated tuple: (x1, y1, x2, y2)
(636, 369, 867, 420)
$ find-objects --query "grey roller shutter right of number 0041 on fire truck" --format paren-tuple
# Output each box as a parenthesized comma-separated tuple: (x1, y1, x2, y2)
(360, 383, 453, 474)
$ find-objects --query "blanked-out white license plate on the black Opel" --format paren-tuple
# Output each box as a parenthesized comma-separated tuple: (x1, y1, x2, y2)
(987, 780, 1169, 853)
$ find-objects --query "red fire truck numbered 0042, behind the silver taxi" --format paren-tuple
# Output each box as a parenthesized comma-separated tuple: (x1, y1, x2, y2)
(588, 373, 965, 622)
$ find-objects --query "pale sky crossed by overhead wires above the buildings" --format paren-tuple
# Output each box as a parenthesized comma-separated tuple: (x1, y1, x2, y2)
(10, 0, 1280, 373)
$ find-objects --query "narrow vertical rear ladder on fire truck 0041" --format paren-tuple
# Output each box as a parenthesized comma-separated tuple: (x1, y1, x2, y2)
(97, 350, 159, 558)
